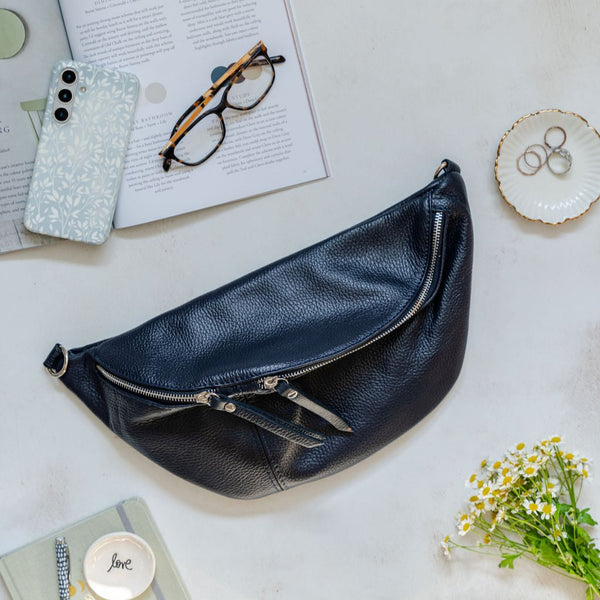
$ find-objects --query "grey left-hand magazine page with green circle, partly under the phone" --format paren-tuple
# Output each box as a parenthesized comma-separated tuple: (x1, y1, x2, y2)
(0, 0, 71, 252)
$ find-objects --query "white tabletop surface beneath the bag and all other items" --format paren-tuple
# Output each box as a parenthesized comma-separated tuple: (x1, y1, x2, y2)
(0, 0, 600, 600)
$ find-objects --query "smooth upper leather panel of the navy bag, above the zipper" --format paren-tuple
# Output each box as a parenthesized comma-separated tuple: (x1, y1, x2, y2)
(90, 174, 466, 391)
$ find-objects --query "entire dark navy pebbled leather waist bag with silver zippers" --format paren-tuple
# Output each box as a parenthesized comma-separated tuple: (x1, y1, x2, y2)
(44, 161, 472, 498)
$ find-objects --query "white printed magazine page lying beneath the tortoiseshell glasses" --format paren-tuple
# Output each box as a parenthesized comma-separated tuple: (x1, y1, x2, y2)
(61, 0, 328, 227)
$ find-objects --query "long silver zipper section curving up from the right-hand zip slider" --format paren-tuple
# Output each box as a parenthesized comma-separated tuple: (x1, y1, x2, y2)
(258, 212, 444, 390)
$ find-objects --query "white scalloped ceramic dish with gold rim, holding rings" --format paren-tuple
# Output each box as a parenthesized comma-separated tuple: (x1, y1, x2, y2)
(495, 109, 600, 225)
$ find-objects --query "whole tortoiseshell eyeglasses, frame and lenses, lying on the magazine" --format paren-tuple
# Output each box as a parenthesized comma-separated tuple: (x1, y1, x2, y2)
(159, 42, 285, 171)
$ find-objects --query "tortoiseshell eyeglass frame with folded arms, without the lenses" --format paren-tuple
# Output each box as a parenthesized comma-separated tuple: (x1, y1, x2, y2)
(158, 41, 285, 171)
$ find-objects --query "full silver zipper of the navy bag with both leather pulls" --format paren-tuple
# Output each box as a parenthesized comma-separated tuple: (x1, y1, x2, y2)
(96, 211, 444, 448)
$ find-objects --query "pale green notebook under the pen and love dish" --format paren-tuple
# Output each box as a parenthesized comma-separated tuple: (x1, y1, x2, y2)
(0, 498, 190, 600)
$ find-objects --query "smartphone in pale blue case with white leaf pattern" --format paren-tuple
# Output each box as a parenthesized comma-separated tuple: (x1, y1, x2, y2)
(24, 60, 139, 244)
